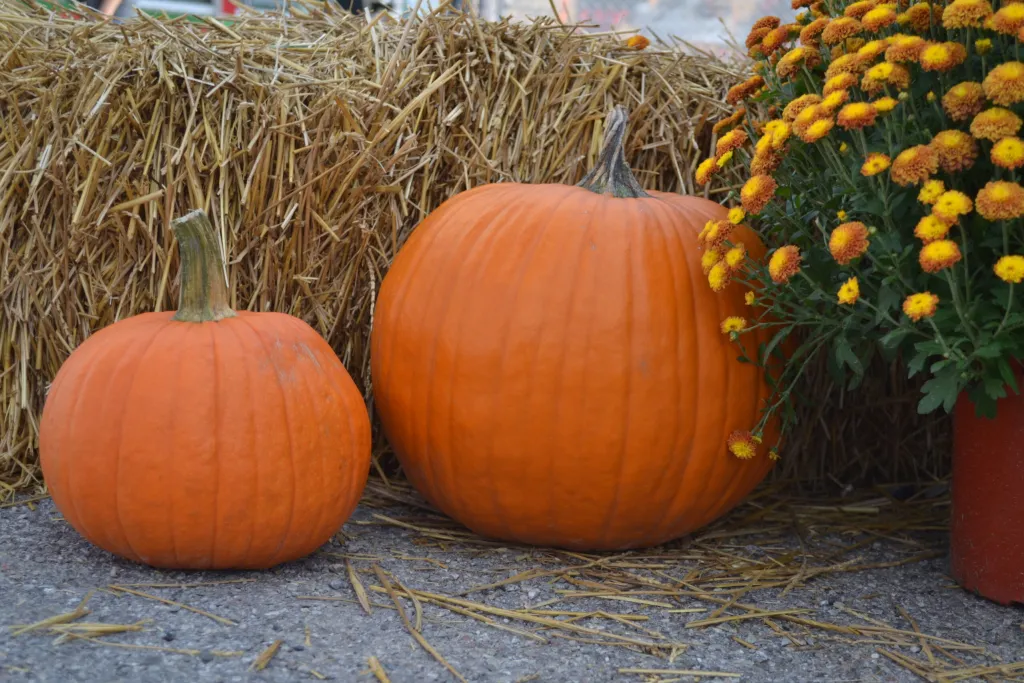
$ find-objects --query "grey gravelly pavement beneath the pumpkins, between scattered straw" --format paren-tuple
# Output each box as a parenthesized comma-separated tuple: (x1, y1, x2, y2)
(0, 501, 1024, 683)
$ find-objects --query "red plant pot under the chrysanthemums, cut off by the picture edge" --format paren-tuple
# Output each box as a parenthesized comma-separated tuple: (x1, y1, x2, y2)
(950, 387, 1024, 605)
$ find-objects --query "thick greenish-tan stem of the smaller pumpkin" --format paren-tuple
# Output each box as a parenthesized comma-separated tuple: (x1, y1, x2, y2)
(171, 210, 234, 323)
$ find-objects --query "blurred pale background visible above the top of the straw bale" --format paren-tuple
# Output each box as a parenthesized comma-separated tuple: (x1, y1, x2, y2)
(88, 0, 794, 51)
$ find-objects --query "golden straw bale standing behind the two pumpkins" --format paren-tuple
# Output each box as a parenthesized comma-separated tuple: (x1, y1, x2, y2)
(0, 2, 736, 496)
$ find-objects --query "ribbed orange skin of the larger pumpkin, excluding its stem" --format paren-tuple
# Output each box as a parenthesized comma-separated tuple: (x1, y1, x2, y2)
(371, 183, 776, 550)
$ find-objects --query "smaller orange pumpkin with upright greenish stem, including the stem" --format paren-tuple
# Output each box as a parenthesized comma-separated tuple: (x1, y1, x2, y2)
(40, 212, 370, 569)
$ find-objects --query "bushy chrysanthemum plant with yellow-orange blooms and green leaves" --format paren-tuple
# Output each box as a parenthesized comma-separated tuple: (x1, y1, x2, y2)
(696, 0, 1024, 464)
